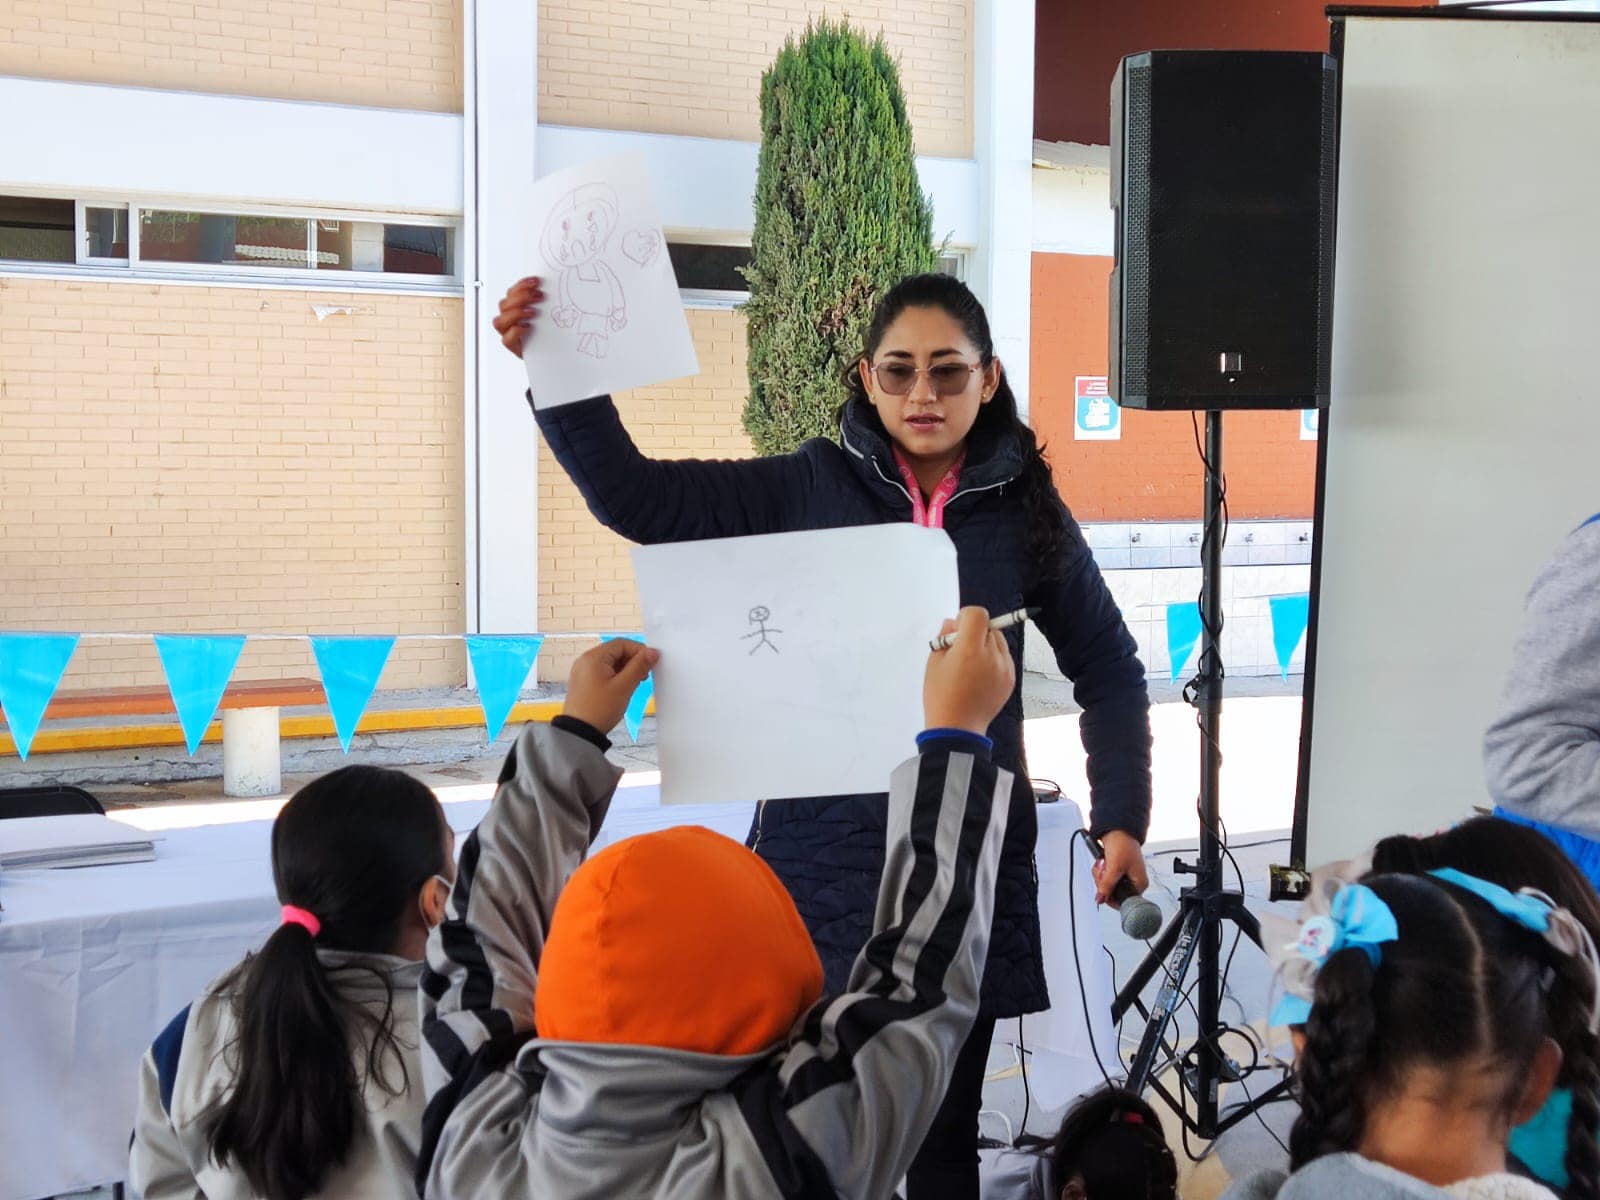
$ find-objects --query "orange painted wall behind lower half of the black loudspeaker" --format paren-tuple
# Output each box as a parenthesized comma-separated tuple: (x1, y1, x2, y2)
(1030, 254, 1317, 522)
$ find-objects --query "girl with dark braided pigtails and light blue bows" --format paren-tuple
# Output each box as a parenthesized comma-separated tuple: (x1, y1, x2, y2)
(1226, 867, 1600, 1200)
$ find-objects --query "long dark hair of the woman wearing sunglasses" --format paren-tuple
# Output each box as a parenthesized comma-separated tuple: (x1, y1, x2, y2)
(840, 274, 1067, 576)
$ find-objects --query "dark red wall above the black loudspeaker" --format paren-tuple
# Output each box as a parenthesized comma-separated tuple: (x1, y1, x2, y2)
(1034, 0, 1427, 146)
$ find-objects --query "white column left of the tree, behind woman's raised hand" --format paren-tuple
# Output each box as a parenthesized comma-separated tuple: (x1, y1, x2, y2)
(462, 0, 539, 634)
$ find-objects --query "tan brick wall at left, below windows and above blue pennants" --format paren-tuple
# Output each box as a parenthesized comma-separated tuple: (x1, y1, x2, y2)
(0, 278, 466, 688)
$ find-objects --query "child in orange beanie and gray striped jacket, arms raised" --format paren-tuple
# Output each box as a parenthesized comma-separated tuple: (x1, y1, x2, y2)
(418, 608, 1014, 1200)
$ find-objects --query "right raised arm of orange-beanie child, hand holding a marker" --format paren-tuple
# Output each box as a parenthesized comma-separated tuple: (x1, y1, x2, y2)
(738, 608, 1014, 1197)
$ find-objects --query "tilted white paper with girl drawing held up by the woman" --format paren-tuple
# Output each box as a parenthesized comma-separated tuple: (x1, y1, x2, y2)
(522, 155, 699, 408)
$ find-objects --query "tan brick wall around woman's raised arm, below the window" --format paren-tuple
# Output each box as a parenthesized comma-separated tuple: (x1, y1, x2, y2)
(539, 309, 754, 680)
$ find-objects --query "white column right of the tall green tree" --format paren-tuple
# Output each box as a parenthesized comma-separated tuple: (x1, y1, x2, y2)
(971, 0, 1034, 418)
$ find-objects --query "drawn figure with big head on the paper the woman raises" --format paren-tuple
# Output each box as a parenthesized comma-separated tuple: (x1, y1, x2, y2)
(539, 184, 627, 358)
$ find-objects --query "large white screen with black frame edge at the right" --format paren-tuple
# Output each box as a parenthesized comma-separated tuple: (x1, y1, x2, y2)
(1301, 16, 1600, 866)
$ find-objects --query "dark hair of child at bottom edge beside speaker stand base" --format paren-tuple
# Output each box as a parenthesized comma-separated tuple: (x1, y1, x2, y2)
(1046, 1088, 1178, 1200)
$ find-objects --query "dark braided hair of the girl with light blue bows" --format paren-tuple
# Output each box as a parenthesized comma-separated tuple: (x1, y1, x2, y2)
(1290, 874, 1600, 1200)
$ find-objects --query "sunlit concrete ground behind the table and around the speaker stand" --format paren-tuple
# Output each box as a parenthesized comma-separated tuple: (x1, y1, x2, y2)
(65, 675, 1301, 1200)
